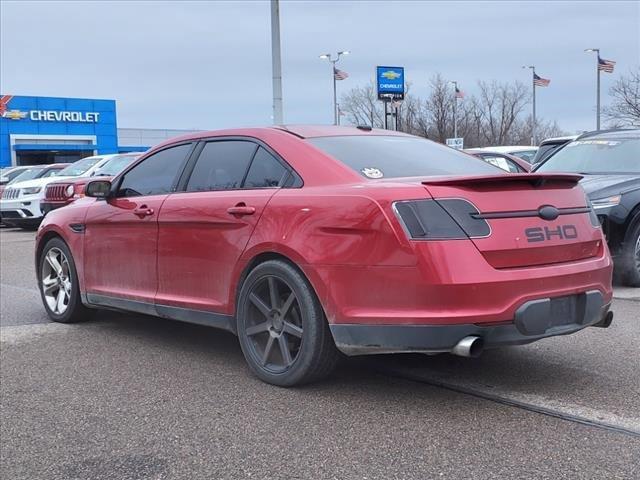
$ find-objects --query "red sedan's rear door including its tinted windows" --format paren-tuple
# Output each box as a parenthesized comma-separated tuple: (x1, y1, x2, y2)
(156, 139, 293, 314)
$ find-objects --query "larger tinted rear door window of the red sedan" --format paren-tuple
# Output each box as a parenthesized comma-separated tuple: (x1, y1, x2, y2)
(186, 140, 258, 192)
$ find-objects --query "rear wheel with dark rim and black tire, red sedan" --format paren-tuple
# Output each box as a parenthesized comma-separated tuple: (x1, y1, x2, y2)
(237, 260, 340, 387)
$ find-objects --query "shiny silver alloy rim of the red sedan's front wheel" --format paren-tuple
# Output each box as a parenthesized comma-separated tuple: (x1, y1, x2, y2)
(41, 247, 72, 315)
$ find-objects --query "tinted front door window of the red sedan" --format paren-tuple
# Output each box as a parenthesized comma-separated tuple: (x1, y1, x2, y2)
(118, 143, 191, 197)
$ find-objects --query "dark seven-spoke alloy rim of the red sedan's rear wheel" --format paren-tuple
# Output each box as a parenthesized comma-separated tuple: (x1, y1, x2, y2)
(244, 276, 303, 373)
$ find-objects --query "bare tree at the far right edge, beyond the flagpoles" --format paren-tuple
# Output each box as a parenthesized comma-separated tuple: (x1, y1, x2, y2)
(604, 68, 640, 127)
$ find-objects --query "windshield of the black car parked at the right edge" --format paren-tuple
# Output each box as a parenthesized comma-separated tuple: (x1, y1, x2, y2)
(536, 138, 640, 175)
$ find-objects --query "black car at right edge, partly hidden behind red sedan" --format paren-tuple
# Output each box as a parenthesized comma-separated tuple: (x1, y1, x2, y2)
(535, 129, 640, 287)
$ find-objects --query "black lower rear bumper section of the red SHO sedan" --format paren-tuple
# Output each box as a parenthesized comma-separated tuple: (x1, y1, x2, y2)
(330, 290, 610, 355)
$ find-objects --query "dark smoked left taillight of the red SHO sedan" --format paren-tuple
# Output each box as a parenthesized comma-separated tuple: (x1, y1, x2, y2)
(393, 198, 491, 240)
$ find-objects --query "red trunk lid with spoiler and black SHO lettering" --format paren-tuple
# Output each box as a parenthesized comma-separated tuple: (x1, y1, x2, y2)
(422, 174, 603, 268)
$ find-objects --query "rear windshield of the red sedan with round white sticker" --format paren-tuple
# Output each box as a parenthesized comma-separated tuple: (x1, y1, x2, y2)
(308, 135, 505, 179)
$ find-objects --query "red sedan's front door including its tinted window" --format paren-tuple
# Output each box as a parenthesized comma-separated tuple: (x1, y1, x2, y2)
(84, 143, 193, 306)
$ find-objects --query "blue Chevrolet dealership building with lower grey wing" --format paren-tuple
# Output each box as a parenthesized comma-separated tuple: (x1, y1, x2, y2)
(0, 95, 192, 167)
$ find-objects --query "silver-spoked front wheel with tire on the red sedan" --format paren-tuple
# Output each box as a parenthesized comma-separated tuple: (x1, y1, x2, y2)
(37, 238, 92, 323)
